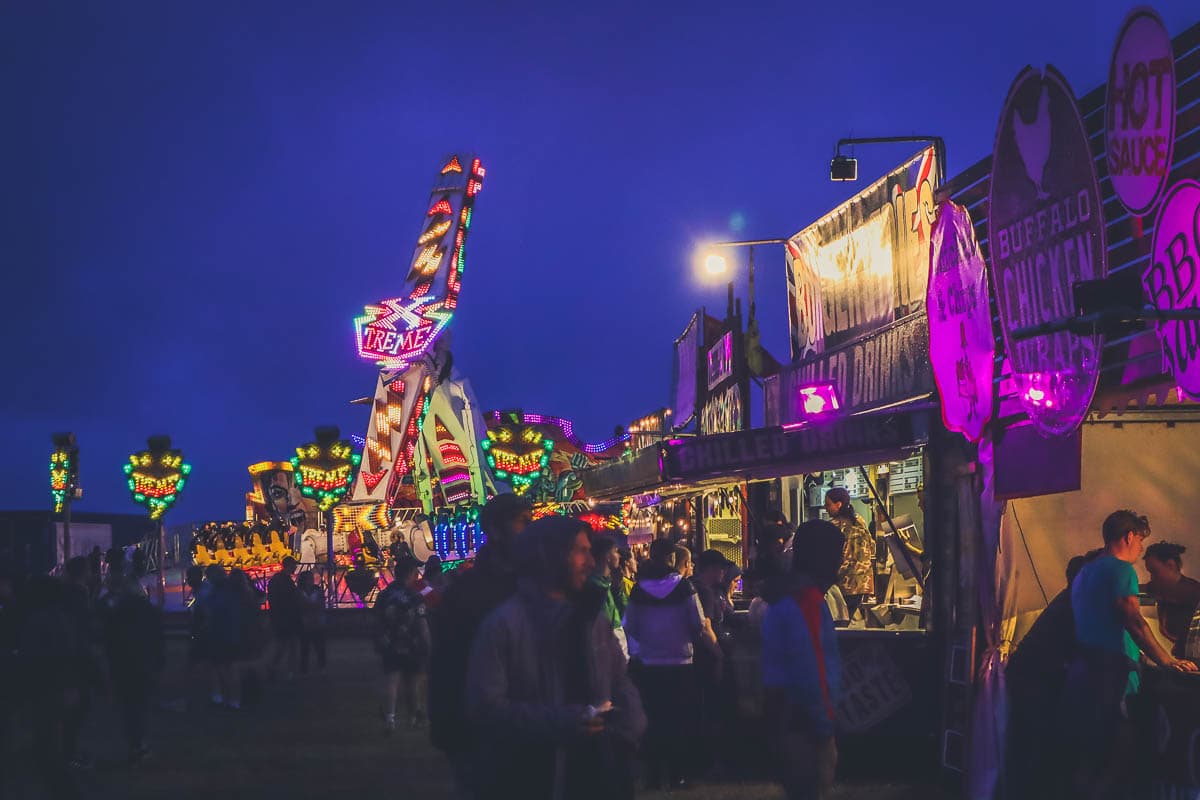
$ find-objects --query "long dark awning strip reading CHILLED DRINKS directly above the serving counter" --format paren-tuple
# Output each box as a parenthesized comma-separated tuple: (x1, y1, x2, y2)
(662, 409, 929, 486)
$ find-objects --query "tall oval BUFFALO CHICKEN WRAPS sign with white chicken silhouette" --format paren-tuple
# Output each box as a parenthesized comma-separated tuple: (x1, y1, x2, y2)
(988, 66, 1108, 435)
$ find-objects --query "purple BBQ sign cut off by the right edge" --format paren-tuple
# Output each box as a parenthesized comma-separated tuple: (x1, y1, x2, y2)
(1141, 181, 1200, 399)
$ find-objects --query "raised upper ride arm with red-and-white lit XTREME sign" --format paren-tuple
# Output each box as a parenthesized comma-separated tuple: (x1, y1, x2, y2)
(354, 155, 484, 368)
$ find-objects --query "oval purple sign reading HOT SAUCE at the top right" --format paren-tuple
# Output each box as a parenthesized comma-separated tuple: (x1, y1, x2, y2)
(1104, 7, 1175, 216)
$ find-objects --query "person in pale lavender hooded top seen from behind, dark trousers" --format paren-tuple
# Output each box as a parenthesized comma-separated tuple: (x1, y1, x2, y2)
(624, 539, 720, 789)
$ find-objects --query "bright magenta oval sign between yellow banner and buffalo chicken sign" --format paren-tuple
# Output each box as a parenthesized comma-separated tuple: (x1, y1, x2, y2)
(928, 203, 996, 441)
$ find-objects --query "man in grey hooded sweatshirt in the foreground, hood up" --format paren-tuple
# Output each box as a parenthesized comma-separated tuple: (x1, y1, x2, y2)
(467, 517, 646, 800)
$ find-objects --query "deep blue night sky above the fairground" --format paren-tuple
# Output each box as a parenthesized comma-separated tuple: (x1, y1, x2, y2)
(0, 0, 1200, 524)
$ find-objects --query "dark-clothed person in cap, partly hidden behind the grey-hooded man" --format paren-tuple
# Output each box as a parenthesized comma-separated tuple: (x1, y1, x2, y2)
(428, 494, 533, 796)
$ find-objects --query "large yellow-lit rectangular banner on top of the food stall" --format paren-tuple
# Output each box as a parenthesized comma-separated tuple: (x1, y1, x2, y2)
(787, 148, 938, 361)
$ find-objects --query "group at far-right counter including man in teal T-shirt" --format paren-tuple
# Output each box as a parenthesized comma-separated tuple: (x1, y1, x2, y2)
(1004, 510, 1200, 800)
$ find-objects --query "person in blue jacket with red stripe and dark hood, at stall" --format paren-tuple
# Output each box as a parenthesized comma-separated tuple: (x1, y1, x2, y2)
(762, 519, 846, 800)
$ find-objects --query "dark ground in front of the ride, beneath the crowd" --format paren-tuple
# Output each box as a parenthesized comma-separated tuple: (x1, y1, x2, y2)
(5, 638, 940, 800)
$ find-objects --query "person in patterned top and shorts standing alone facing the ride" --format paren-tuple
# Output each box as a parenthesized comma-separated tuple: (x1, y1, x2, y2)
(374, 558, 432, 735)
